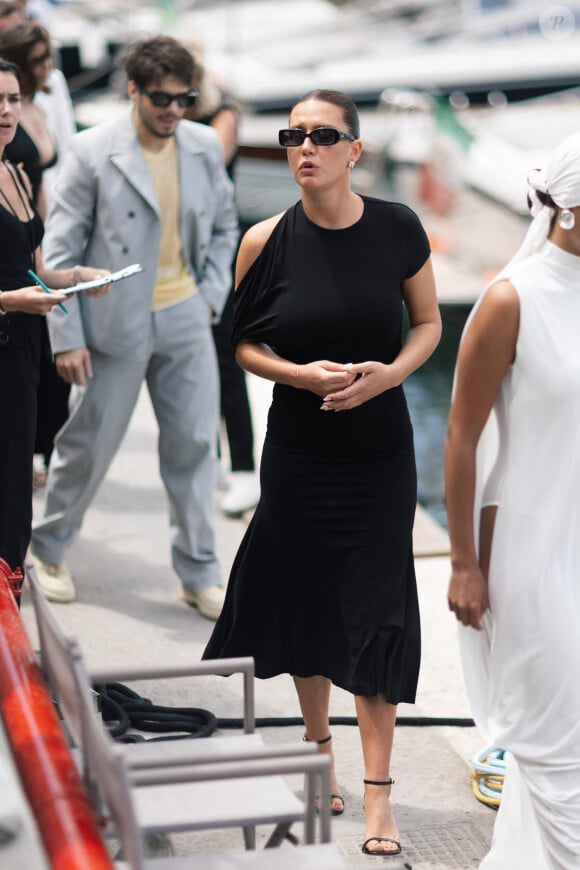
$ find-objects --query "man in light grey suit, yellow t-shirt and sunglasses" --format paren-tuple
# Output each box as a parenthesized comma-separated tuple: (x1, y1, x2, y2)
(32, 36, 238, 619)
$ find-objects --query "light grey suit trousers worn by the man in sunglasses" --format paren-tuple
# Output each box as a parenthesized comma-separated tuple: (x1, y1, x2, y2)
(32, 296, 222, 591)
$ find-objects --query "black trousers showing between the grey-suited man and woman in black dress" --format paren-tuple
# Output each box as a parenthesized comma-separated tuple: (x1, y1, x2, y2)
(213, 292, 255, 471)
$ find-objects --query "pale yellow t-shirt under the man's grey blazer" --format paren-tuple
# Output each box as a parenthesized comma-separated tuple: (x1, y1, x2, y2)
(143, 138, 197, 311)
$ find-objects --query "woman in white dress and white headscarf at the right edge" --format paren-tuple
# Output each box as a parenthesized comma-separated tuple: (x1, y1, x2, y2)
(446, 135, 580, 870)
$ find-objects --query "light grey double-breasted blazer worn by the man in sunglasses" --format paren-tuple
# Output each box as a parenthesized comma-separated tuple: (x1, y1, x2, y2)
(43, 109, 238, 359)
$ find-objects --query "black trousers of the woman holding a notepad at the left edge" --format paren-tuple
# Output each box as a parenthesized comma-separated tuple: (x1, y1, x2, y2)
(0, 330, 46, 569)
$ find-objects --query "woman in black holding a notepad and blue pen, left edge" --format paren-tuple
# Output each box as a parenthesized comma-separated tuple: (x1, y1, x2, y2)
(0, 58, 110, 604)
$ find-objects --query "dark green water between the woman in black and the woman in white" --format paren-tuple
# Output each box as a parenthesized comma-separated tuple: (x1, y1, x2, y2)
(405, 305, 469, 527)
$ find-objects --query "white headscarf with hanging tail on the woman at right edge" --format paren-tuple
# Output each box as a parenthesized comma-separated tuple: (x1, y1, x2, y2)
(493, 133, 580, 284)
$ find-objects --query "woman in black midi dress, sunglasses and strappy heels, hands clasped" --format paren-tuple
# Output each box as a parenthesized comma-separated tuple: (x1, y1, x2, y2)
(204, 91, 441, 855)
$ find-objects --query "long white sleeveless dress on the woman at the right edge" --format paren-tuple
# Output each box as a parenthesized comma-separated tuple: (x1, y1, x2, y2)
(460, 242, 580, 870)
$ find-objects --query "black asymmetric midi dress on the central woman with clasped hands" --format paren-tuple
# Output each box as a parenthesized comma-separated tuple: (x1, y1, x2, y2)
(204, 197, 429, 704)
